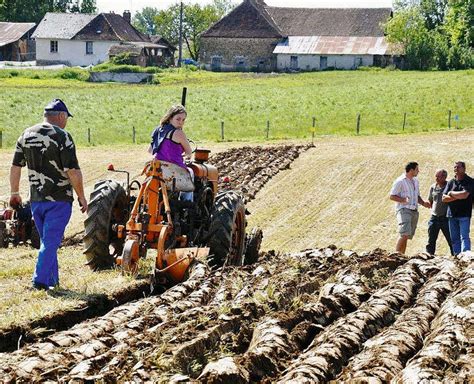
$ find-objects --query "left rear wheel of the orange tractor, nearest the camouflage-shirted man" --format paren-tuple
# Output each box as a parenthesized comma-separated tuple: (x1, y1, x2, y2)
(84, 180, 128, 270)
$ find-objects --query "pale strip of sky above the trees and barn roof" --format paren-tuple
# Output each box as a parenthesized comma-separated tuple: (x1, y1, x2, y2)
(96, 0, 392, 13)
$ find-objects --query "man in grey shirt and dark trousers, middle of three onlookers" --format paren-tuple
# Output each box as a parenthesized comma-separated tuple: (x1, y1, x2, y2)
(426, 169, 453, 255)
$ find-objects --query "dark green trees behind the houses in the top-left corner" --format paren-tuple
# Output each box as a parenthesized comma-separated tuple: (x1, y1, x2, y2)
(0, 0, 96, 23)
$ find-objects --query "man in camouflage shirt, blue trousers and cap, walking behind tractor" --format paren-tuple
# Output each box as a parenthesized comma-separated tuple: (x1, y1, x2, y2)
(10, 99, 87, 290)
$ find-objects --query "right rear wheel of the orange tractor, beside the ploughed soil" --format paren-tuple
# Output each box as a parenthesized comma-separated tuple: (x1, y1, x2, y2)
(208, 191, 246, 268)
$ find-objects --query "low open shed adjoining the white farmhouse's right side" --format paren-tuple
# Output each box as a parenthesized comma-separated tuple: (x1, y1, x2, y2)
(109, 42, 167, 67)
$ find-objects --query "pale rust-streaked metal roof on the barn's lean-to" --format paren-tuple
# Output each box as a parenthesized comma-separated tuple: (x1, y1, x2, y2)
(273, 36, 389, 55)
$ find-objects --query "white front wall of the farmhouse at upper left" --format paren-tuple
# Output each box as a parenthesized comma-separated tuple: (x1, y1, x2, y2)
(36, 39, 117, 66)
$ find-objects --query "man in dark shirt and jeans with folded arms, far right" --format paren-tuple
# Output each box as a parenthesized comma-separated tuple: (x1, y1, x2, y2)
(443, 161, 474, 255)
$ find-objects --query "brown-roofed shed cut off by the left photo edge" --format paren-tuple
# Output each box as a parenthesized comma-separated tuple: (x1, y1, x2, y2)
(0, 22, 36, 61)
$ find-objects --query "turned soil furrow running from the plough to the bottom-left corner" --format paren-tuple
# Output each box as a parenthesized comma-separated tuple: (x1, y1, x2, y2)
(0, 264, 209, 382)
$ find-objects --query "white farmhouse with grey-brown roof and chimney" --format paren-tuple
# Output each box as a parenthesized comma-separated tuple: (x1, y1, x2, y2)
(33, 11, 150, 66)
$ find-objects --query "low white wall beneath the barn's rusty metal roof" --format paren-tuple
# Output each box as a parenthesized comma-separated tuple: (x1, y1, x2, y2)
(277, 54, 374, 71)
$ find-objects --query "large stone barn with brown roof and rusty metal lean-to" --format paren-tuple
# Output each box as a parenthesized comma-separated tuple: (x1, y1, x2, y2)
(200, 0, 392, 70)
